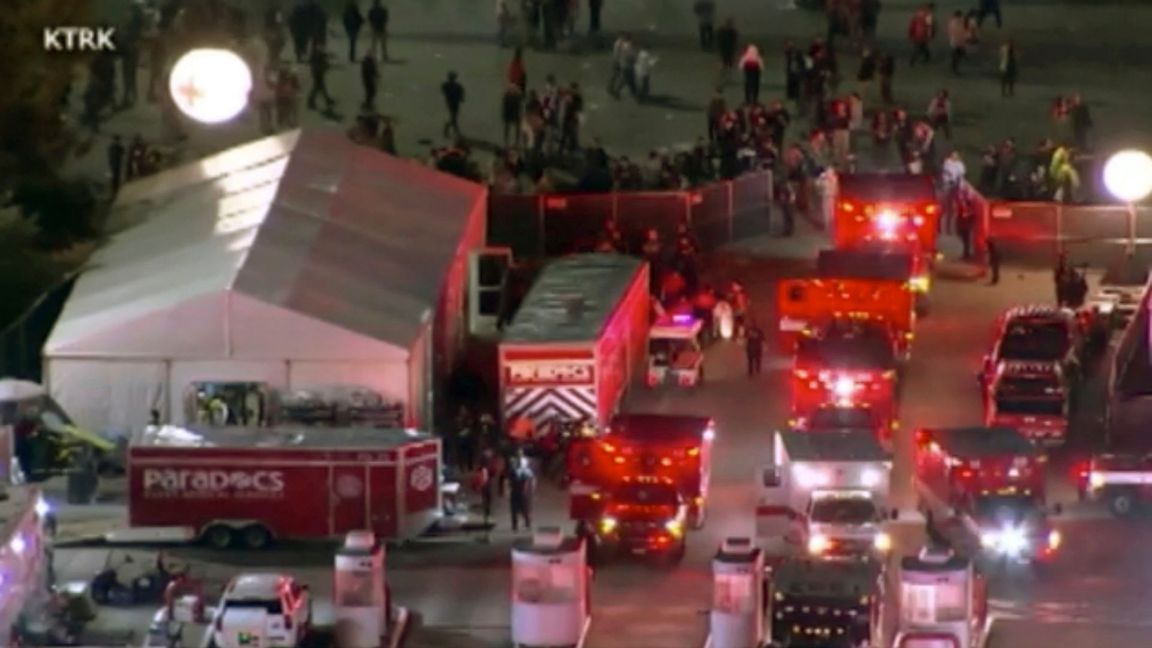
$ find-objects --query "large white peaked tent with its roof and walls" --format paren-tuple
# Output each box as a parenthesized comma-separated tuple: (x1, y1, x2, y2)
(44, 130, 486, 431)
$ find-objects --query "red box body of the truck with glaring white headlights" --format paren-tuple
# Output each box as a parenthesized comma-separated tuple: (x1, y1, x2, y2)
(914, 428, 1047, 519)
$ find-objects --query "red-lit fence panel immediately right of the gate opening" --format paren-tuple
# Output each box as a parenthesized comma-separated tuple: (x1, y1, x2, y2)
(988, 202, 1060, 266)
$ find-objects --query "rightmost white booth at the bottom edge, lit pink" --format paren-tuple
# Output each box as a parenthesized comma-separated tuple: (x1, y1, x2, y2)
(893, 548, 988, 648)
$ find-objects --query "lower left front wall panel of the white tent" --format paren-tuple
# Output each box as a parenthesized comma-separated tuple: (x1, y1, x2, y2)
(44, 356, 170, 434)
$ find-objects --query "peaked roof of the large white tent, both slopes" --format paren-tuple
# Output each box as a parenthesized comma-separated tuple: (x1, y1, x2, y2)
(45, 130, 486, 355)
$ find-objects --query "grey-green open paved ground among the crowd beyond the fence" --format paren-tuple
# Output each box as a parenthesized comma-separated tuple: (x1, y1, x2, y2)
(78, 0, 1152, 187)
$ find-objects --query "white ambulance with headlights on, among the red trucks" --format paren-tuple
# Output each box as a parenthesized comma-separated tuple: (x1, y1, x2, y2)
(757, 430, 896, 558)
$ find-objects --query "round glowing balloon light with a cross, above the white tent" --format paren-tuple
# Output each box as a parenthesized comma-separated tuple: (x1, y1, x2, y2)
(168, 50, 252, 123)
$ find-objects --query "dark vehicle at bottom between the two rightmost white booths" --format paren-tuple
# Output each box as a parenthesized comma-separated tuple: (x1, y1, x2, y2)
(768, 559, 885, 648)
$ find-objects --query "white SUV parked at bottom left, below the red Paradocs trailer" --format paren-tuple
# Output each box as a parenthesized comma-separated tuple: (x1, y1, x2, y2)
(211, 574, 312, 648)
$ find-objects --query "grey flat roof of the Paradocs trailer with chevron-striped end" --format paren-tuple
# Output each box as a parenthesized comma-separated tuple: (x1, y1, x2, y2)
(503, 253, 645, 344)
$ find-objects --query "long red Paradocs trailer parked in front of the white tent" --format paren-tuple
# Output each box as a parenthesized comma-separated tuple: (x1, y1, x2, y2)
(126, 427, 441, 549)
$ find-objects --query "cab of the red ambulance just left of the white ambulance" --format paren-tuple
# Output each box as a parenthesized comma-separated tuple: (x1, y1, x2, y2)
(582, 476, 688, 564)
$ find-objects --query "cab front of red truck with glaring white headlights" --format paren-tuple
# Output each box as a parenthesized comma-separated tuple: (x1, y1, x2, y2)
(969, 495, 1063, 564)
